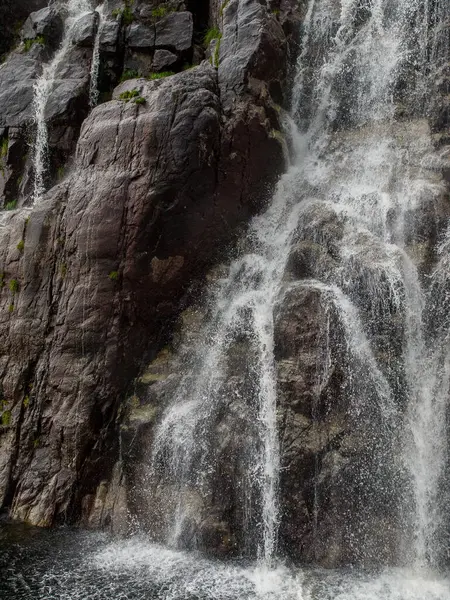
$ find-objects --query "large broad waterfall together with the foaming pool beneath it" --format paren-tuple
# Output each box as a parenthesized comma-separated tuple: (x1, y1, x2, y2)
(0, 0, 450, 600)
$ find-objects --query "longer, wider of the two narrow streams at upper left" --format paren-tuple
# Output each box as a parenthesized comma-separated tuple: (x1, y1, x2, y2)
(33, 0, 92, 203)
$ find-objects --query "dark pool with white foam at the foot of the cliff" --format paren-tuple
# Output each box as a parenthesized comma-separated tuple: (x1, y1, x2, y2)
(0, 525, 450, 600)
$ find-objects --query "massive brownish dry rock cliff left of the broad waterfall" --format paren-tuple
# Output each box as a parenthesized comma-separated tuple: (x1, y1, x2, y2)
(0, 0, 302, 526)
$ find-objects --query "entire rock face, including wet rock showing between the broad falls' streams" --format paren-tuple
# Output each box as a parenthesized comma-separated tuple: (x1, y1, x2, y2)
(6, 0, 449, 566)
